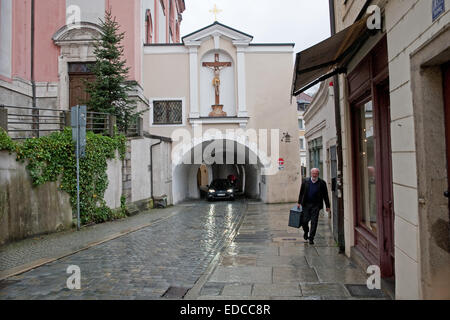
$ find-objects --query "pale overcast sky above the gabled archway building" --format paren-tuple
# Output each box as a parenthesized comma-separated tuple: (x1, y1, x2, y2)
(181, 0, 330, 93)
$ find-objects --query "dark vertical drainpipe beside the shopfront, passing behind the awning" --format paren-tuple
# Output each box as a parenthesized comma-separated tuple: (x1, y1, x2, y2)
(329, 0, 345, 253)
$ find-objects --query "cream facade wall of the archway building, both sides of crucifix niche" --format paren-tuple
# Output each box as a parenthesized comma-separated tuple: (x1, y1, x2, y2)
(144, 32, 301, 203)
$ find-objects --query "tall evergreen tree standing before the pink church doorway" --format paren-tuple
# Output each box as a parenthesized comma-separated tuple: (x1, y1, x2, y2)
(86, 11, 141, 133)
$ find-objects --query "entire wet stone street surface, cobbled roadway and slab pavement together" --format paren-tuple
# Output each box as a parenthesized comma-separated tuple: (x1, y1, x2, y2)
(0, 200, 387, 300)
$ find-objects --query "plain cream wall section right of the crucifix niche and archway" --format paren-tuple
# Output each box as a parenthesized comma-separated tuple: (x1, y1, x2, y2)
(246, 53, 301, 203)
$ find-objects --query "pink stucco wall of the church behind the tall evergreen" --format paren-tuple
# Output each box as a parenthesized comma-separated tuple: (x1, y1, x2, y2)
(6, 0, 154, 83)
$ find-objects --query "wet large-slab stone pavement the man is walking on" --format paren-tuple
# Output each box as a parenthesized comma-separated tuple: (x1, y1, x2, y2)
(191, 204, 386, 300)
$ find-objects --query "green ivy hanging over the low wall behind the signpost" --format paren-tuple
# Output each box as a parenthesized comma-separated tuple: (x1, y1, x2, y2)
(0, 128, 126, 224)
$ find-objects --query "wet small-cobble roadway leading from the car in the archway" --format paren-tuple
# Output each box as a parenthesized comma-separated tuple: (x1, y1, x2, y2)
(0, 201, 246, 300)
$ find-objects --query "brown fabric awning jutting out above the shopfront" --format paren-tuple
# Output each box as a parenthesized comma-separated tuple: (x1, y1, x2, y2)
(292, 16, 371, 96)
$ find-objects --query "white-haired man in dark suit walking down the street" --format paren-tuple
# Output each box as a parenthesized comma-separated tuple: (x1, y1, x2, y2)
(297, 168, 330, 244)
